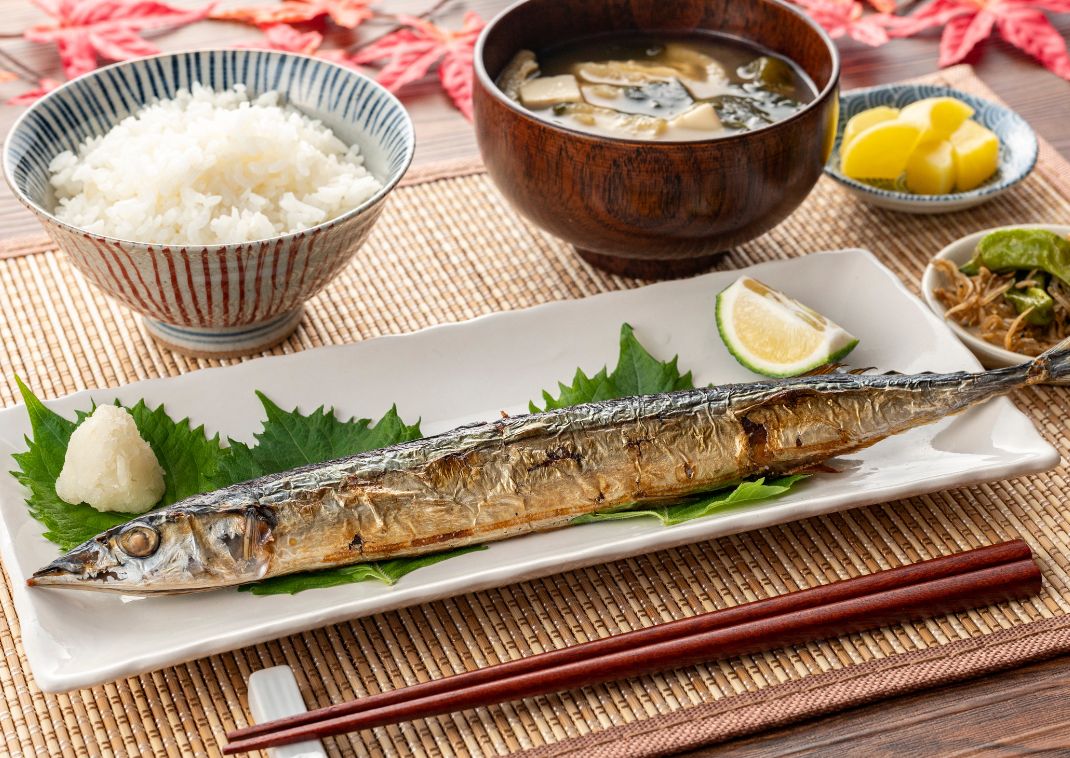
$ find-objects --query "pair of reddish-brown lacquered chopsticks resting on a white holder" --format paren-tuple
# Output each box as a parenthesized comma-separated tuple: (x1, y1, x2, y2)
(224, 540, 1040, 754)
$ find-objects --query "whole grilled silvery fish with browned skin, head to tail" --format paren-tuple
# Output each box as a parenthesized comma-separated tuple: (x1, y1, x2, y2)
(29, 343, 1070, 594)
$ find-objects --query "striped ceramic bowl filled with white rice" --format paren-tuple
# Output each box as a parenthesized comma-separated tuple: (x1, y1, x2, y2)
(3, 50, 414, 357)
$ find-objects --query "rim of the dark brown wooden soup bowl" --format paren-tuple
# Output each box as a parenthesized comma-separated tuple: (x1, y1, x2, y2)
(473, 0, 841, 148)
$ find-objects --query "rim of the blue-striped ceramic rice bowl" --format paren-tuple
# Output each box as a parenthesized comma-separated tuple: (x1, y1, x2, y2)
(0, 47, 416, 253)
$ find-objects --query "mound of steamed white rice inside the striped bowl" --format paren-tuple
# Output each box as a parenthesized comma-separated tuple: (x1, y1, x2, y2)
(48, 84, 382, 245)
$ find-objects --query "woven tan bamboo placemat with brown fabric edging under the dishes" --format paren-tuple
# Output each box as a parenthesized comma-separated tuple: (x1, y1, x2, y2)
(0, 67, 1070, 756)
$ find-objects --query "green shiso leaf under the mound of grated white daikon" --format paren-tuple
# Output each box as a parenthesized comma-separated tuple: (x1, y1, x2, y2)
(12, 377, 221, 550)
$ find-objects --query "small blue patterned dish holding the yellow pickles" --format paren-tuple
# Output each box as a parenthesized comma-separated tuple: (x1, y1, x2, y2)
(825, 85, 1037, 213)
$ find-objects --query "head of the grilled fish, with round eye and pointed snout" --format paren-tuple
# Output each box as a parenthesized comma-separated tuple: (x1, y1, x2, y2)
(28, 505, 275, 594)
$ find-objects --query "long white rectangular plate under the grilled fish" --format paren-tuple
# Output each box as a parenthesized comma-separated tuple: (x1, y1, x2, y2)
(0, 251, 1058, 692)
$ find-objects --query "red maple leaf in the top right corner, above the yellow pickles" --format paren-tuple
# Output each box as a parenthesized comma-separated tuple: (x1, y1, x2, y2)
(890, 0, 1070, 79)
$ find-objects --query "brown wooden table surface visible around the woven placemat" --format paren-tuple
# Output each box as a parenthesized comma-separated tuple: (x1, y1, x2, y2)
(0, 0, 1070, 758)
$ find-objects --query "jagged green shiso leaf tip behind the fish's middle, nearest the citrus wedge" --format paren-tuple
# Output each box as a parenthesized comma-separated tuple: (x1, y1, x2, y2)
(529, 323, 694, 413)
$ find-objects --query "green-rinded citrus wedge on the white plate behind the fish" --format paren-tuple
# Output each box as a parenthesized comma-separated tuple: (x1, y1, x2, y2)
(717, 276, 858, 377)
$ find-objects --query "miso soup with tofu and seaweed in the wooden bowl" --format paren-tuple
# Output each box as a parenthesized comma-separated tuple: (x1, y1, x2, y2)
(498, 32, 815, 140)
